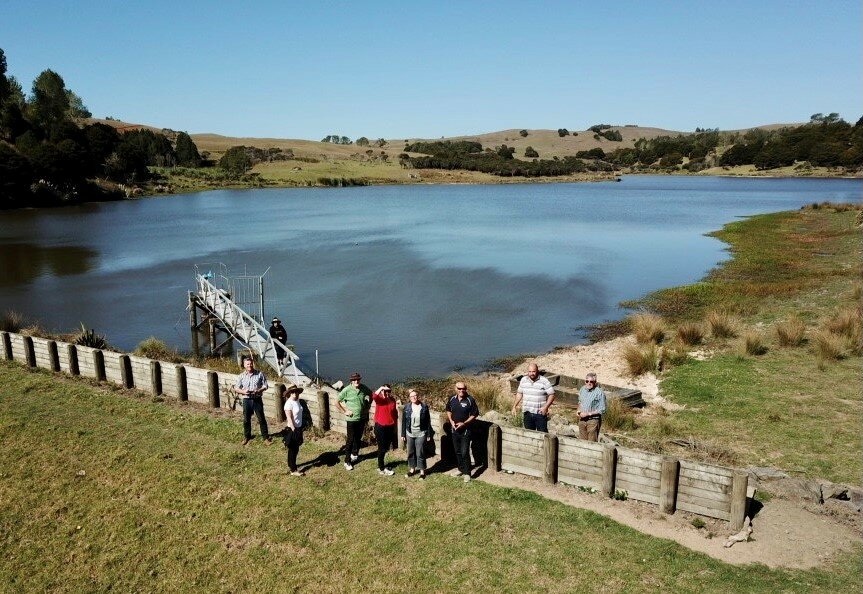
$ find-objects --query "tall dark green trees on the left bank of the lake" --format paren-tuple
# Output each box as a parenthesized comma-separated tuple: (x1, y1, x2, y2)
(0, 49, 202, 208)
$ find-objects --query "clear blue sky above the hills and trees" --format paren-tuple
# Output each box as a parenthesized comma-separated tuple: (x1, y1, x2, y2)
(0, 0, 863, 140)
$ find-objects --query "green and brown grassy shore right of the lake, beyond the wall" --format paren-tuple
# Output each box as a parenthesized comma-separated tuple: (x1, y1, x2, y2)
(625, 208, 863, 484)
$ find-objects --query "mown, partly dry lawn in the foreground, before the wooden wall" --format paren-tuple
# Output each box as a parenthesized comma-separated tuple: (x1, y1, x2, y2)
(0, 362, 863, 593)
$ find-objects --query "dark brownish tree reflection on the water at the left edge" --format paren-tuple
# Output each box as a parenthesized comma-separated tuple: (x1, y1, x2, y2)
(0, 243, 98, 287)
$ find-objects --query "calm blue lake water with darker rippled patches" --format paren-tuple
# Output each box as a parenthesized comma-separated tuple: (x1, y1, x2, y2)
(0, 176, 863, 383)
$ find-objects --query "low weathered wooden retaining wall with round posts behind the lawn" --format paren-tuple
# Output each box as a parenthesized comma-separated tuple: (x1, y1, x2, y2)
(0, 332, 748, 530)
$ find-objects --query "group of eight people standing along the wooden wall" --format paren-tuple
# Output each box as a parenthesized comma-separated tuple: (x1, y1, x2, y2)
(234, 357, 607, 482)
